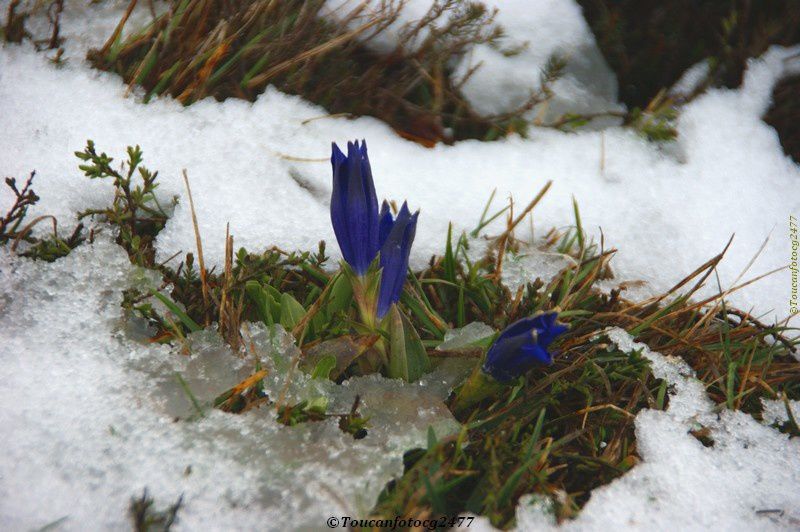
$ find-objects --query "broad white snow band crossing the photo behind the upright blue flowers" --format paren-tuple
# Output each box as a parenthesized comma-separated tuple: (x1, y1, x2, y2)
(0, 2, 800, 319)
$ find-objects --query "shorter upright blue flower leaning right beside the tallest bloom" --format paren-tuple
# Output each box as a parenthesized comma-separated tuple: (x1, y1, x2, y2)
(378, 201, 419, 318)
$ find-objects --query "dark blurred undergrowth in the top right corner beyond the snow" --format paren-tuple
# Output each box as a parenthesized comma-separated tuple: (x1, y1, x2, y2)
(577, 0, 800, 162)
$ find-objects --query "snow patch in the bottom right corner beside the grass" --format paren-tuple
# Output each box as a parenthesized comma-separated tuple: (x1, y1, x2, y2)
(506, 328, 800, 530)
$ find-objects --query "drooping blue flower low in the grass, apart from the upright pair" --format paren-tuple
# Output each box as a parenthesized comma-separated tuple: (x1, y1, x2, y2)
(483, 312, 567, 382)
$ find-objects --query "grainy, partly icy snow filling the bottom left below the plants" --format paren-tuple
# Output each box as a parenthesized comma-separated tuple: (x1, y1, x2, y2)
(0, 235, 464, 530)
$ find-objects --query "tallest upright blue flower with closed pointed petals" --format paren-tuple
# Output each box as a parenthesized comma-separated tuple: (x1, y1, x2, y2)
(331, 141, 379, 275)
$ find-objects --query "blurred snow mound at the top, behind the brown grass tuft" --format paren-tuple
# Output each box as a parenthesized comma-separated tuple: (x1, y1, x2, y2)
(326, 0, 624, 121)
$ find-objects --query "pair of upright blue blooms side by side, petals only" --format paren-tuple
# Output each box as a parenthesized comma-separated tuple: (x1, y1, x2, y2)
(331, 141, 419, 319)
